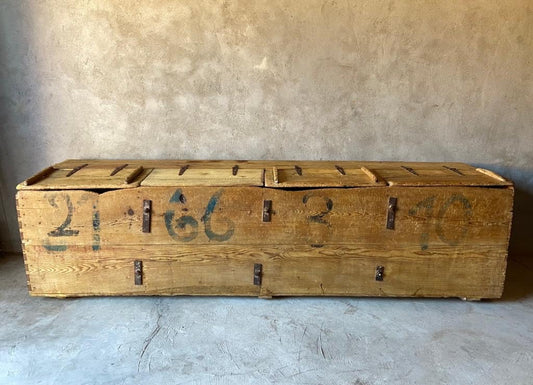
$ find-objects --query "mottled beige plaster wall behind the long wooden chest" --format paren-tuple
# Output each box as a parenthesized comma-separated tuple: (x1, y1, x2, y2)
(0, 0, 533, 250)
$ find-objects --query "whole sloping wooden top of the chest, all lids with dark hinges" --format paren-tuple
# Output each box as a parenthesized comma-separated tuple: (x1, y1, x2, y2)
(17, 160, 512, 190)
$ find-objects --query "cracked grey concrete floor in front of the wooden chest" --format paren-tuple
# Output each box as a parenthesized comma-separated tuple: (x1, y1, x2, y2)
(0, 255, 533, 385)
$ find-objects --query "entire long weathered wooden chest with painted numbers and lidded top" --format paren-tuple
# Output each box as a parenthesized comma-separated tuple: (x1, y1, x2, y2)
(17, 160, 513, 300)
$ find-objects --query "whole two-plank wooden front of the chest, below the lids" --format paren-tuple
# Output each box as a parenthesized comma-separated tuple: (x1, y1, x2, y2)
(17, 183, 513, 298)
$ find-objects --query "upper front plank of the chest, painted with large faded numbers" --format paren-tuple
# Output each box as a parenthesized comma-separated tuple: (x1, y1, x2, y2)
(18, 187, 513, 252)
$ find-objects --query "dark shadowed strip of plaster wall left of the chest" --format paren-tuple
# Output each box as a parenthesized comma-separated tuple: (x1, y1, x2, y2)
(0, 1, 48, 252)
